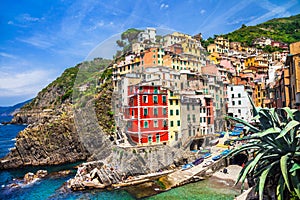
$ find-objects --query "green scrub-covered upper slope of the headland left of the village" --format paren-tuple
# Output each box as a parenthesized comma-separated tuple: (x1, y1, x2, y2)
(22, 58, 111, 110)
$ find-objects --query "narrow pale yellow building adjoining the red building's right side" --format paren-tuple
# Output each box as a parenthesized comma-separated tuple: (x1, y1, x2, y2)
(168, 90, 181, 144)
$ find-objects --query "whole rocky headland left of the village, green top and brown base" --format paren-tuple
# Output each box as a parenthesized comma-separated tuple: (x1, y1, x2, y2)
(0, 59, 114, 169)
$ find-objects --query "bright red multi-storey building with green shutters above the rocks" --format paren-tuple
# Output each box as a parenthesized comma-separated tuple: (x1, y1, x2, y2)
(125, 85, 169, 144)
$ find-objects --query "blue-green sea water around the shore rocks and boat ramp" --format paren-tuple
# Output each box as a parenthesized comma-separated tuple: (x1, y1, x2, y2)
(0, 117, 239, 200)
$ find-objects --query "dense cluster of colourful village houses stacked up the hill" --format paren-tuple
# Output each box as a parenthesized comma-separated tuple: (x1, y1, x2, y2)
(111, 28, 300, 147)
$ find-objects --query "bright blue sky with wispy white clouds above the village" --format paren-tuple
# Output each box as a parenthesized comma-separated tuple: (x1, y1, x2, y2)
(0, 0, 300, 106)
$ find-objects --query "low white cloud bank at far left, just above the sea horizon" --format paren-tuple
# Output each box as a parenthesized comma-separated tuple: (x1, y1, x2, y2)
(0, 70, 52, 97)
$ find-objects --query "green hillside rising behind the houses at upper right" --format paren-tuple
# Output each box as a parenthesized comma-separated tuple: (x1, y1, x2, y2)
(207, 14, 300, 46)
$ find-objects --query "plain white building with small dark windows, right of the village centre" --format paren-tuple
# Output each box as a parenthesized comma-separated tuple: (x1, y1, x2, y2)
(227, 85, 252, 122)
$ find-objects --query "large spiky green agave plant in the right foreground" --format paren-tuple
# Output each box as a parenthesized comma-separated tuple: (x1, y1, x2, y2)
(227, 99, 300, 199)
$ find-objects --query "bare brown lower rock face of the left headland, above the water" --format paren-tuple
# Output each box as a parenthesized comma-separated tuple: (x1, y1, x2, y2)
(0, 105, 89, 169)
